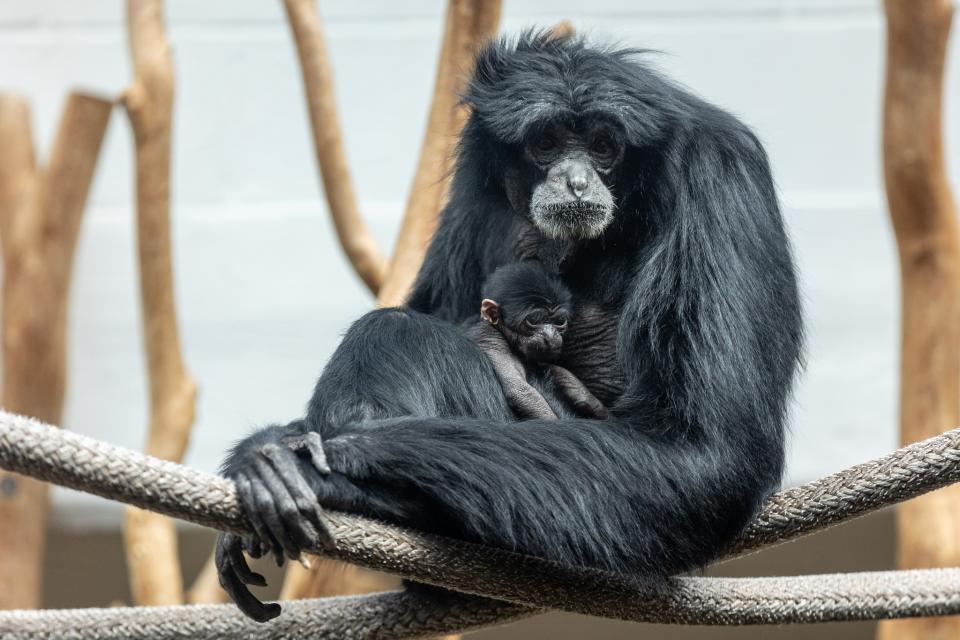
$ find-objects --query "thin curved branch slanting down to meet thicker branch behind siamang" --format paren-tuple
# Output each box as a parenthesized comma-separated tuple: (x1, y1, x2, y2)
(283, 0, 387, 294)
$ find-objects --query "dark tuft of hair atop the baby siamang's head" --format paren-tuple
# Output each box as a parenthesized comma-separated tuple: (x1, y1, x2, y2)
(481, 260, 571, 314)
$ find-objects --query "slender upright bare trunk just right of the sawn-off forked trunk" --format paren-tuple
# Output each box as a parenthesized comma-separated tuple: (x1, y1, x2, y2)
(123, 0, 196, 605)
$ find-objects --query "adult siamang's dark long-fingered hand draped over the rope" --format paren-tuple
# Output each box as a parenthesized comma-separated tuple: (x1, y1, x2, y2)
(216, 432, 335, 622)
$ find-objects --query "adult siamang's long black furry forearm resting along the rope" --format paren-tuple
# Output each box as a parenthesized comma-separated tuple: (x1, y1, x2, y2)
(318, 418, 758, 577)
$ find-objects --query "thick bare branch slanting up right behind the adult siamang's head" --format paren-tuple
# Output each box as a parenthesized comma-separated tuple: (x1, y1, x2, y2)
(377, 0, 501, 307)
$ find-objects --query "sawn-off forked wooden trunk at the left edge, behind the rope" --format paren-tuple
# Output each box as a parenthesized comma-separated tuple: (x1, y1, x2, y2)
(0, 93, 113, 608)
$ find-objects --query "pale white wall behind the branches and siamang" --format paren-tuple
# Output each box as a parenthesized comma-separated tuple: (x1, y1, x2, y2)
(0, 0, 928, 525)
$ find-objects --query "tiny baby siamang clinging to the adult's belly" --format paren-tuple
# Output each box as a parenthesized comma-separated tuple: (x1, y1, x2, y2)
(466, 261, 608, 420)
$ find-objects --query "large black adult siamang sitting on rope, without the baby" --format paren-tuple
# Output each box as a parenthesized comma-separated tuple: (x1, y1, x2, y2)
(217, 33, 801, 620)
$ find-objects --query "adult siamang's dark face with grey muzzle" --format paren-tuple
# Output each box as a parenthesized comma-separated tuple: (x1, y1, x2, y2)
(507, 118, 624, 239)
